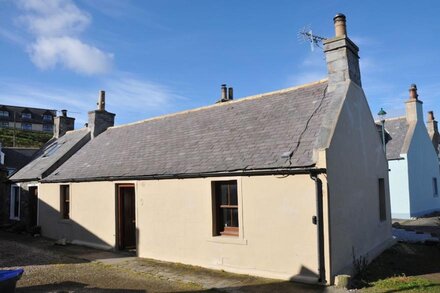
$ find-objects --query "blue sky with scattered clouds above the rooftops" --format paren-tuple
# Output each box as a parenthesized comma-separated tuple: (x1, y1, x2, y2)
(0, 0, 440, 127)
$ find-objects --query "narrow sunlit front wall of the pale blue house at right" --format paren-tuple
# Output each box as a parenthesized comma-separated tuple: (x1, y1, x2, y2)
(388, 154, 411, 219)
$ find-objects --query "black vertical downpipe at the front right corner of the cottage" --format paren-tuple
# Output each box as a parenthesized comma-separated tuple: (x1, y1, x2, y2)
(310, 172, 327, 284)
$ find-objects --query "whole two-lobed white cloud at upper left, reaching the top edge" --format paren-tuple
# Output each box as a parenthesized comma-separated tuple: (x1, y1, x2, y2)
(17, 0, 113, 75)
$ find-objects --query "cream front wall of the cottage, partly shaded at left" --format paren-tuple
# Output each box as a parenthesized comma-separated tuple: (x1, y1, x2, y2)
(39, 175, 326, 282)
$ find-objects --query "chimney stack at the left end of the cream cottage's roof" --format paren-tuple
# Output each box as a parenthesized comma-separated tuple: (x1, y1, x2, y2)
(87, 91, 115, 139)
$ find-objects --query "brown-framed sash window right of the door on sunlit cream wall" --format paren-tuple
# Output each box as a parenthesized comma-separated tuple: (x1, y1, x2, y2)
(212, 180, 239, 236)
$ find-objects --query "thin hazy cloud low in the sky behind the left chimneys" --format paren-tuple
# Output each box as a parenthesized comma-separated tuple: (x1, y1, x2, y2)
(0, 74, 187, 124)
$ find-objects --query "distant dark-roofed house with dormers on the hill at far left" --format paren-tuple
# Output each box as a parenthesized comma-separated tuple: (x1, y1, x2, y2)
(0, 105, 57, 132)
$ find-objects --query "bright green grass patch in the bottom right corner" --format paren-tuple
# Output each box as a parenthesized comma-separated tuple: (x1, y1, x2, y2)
(365, 276, 440, 292)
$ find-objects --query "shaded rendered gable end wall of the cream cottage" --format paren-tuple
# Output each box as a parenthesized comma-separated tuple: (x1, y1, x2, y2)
(326, 81, 392, 276)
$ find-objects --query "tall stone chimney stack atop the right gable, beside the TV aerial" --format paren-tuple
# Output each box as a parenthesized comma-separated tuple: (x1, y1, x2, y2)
(324, 13, 362, 90)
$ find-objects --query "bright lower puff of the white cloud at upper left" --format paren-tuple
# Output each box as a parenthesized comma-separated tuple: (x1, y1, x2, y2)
(29, 37, 113, 74)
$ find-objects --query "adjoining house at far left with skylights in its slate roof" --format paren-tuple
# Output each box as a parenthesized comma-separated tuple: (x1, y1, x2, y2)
(4, 99, 115, 229)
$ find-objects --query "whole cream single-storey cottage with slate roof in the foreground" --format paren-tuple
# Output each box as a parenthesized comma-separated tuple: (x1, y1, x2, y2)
(39, 14, 393, 284)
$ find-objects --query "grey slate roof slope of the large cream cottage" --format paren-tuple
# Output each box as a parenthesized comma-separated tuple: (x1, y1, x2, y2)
(44, 80, 330, 182)
